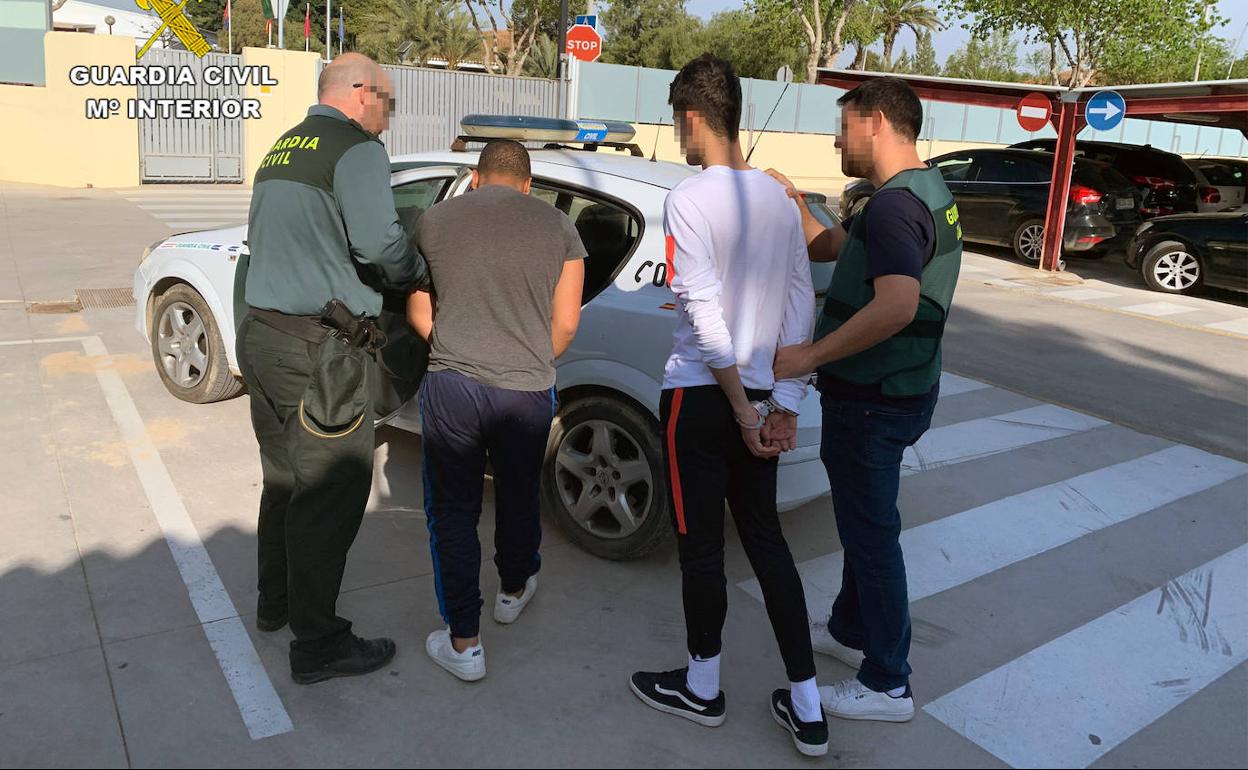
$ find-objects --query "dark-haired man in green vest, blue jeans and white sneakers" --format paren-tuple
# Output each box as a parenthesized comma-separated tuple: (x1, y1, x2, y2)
(775, 77, 962, 721)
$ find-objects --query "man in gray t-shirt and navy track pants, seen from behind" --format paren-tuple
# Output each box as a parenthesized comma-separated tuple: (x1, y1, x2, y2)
(408, 141, 585, 681)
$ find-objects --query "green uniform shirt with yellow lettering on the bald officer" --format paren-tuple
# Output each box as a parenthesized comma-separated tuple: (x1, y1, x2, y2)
(240, 105, 427, 316)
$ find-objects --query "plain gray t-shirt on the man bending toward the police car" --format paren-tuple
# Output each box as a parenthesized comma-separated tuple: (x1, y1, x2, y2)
(416, 185, 585, 391)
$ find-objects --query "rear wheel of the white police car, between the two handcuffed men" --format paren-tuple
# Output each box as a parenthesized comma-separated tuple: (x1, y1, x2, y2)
(542, 396, 671, 560)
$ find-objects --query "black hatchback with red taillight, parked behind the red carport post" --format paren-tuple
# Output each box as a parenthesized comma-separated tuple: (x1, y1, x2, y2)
(841, 150, 1141, 265)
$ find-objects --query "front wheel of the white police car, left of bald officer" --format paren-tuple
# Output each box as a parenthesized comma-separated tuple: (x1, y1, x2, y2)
(151, 283, 243, 403)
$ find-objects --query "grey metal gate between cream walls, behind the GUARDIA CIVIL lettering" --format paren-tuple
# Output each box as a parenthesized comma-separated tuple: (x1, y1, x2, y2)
(139, 49, 243, 182)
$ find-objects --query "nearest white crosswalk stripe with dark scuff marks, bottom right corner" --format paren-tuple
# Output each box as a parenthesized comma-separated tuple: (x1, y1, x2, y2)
(924, 545, 1248, 768)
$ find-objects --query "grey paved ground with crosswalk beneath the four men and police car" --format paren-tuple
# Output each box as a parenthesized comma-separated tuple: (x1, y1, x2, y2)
(0, 187, 1248, 768)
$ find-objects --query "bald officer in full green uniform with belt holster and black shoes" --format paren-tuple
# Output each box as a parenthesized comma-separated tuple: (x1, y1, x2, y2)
(236, 54, 426, 684)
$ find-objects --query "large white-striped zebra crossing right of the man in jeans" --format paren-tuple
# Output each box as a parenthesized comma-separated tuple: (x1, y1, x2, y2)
(739, 374, 1248, 768)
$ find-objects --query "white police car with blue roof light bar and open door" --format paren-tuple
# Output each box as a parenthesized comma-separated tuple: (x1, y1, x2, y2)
(134, 119, 835, 559)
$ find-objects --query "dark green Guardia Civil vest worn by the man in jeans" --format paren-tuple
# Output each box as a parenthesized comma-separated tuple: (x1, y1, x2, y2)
(815, 168, 962, 397)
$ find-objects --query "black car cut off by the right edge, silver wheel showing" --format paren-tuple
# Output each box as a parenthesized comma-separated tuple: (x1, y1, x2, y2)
(1124, 205, 1248, 295)
